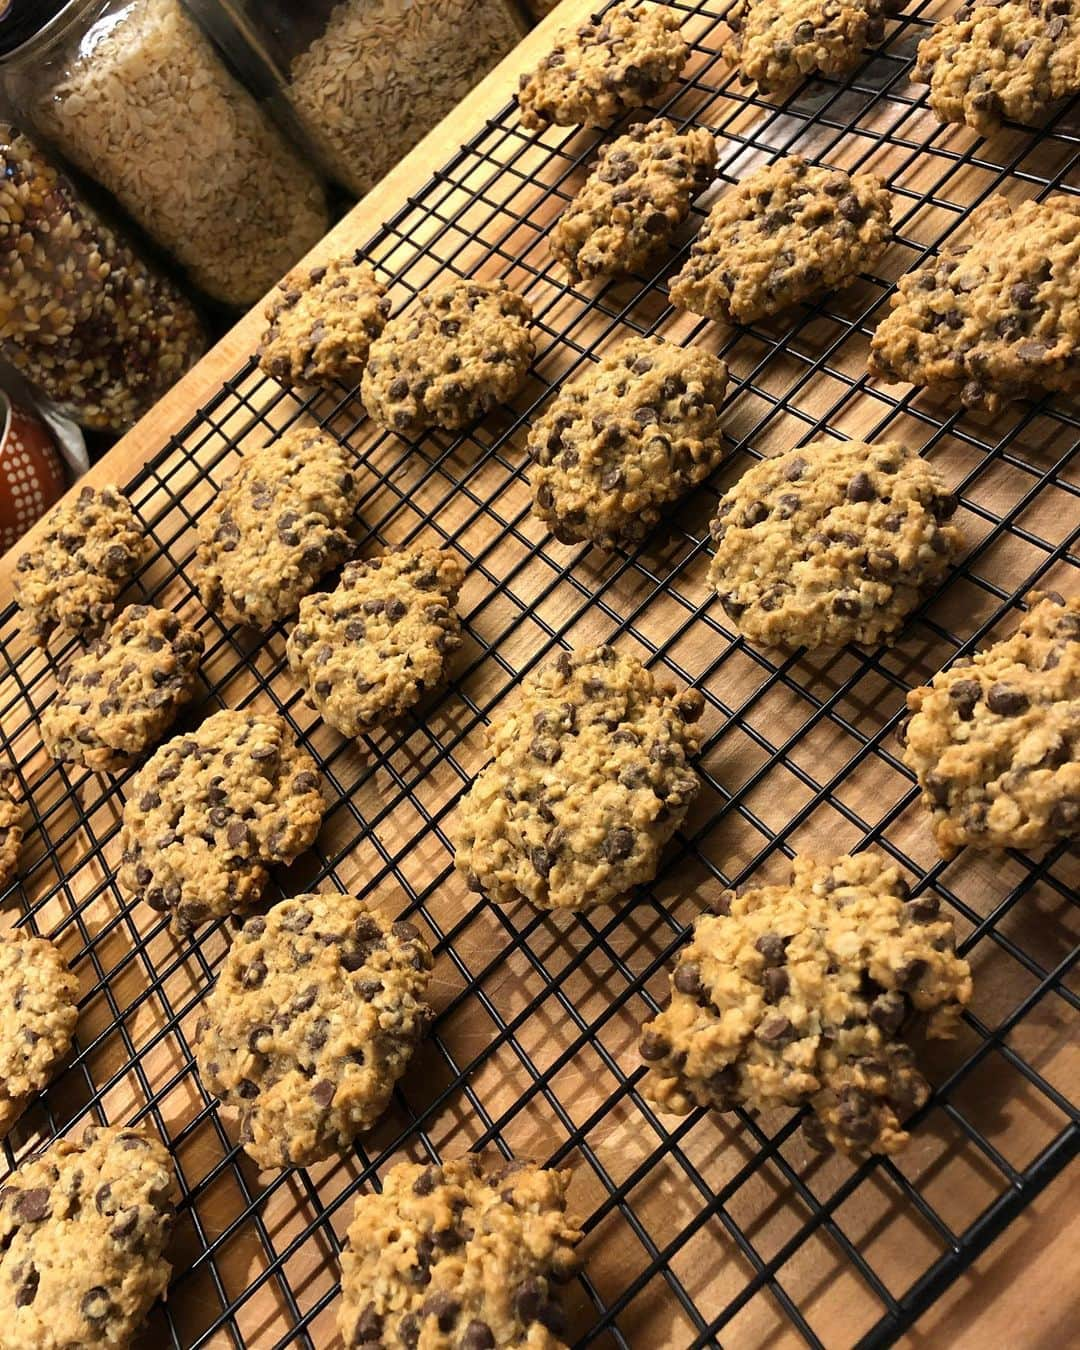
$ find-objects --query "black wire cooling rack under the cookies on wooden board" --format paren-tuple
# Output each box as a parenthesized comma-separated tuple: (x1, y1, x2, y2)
(0, 0, 1080, 1350)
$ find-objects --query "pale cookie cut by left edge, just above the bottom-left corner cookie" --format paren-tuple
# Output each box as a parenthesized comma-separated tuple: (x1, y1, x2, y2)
(0, 929, 78, 1138)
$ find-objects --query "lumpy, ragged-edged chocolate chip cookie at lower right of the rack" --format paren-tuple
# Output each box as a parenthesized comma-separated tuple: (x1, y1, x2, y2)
(641, 853, 971, 1156)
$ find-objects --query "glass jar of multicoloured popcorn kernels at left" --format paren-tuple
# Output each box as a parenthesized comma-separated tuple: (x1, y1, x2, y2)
(0, 124, 205, 432)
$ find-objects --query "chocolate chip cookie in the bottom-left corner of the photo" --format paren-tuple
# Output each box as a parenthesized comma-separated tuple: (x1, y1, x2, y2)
(0, 1125, 176, 1350)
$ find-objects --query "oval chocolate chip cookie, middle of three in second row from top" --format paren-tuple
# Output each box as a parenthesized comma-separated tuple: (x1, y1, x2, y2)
(671, 155, 892, 324)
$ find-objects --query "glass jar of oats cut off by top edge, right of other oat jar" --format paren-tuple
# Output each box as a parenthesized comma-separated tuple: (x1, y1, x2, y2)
(217, 0, 528, 197)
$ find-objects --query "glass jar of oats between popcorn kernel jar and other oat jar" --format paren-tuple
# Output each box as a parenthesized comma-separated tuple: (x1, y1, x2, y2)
(0, 0, 329, 306)
